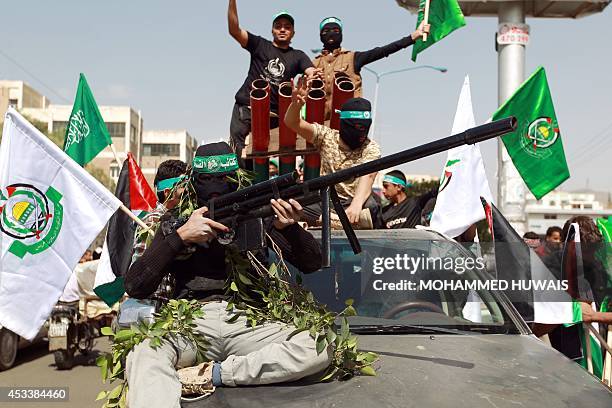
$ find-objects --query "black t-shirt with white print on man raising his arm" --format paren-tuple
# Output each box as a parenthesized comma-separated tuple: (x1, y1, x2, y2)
(236, 33, 312, 111)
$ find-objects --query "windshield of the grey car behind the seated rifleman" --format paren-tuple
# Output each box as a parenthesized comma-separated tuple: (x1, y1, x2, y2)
(292, 230, 519, 334)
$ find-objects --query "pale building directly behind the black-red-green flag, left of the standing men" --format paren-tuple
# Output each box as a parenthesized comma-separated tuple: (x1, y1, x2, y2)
(141, 130, 198, 186)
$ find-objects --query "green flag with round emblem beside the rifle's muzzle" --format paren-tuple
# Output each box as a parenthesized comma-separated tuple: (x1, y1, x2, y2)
(492, 67, 569, 200)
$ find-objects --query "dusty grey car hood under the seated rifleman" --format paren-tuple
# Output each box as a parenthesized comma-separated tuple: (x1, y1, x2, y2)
(184, 335, 612, 408)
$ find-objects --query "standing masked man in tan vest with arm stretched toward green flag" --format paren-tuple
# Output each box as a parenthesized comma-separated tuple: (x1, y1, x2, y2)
(314, 17, 429, 119)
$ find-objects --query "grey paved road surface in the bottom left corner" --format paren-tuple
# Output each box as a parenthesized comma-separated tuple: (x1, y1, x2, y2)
(0, 337, 110, 408)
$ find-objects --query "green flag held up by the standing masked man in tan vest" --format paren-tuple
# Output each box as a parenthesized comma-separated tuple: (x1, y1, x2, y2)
(412, 0, 465, 61)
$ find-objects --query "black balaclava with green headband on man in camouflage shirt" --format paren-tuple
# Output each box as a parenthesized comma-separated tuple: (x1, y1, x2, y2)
(340, 98, 372, 150)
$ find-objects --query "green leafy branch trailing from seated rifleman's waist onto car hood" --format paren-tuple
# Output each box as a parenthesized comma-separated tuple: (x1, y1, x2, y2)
(226, 241, 378, 381)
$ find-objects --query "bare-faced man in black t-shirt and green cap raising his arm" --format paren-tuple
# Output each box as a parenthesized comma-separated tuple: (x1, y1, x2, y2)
(227, 0, 317, 167)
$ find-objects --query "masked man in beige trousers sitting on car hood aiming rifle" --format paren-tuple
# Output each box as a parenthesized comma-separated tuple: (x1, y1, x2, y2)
(125, 142, 332, 408)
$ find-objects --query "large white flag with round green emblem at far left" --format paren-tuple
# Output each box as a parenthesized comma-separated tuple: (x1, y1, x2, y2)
(0, 108, 121, 339)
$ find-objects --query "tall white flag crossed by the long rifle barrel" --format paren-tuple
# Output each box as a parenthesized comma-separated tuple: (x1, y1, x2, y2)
(430, 76, 493, 237)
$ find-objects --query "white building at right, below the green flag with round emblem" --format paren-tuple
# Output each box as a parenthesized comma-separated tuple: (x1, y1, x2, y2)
(525, 191, 612, 235)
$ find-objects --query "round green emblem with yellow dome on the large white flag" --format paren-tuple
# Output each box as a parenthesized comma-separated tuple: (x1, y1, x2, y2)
(0, 184, 63, 258)
